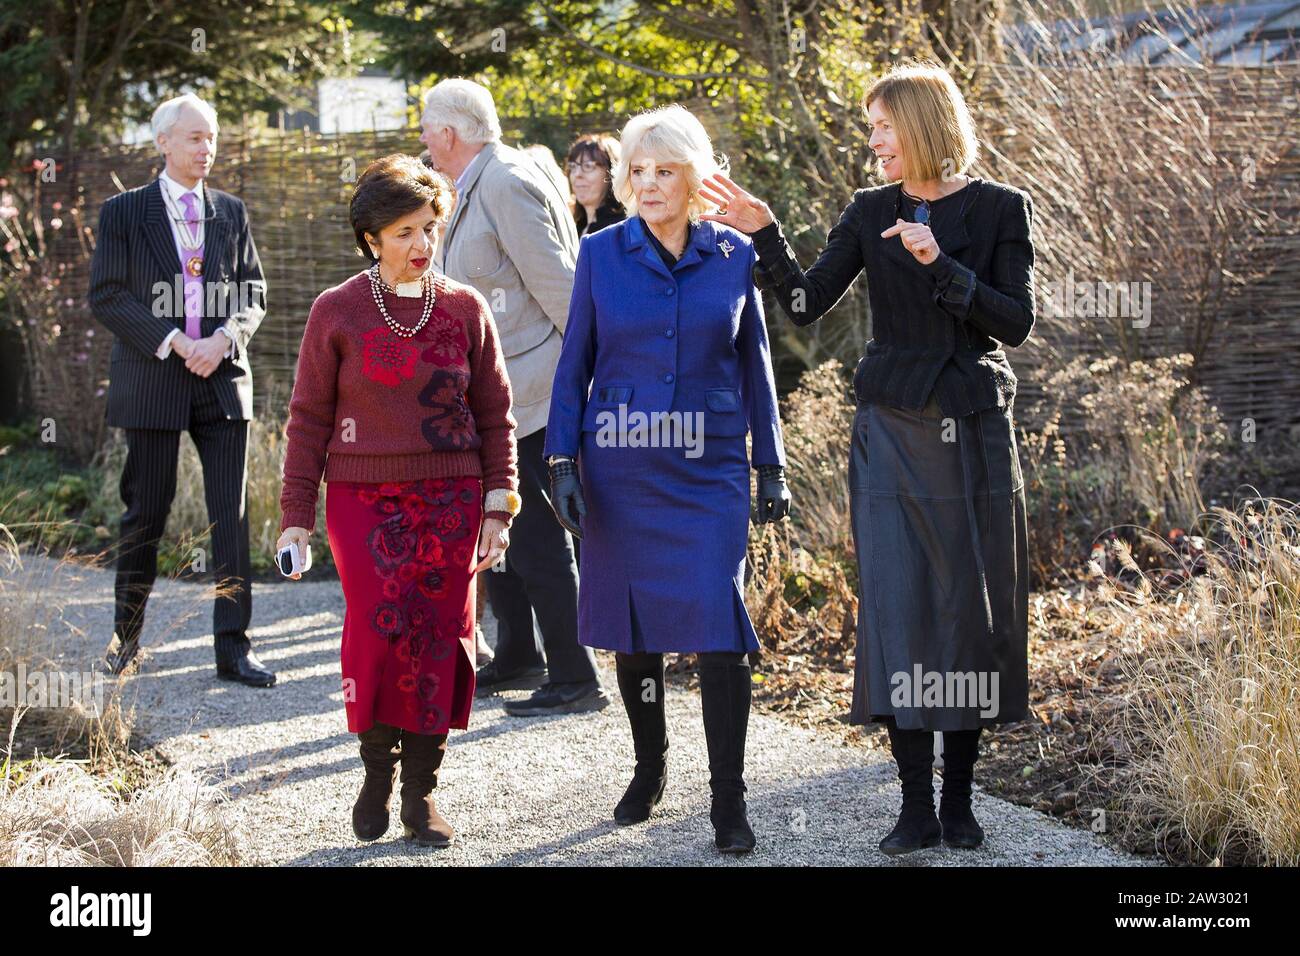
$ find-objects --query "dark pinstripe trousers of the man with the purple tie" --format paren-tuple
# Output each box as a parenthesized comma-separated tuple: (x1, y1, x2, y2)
(113, 378, 252, 659)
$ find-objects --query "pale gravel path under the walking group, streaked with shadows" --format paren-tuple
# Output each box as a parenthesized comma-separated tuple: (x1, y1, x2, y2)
(35, 558, 1152, 866)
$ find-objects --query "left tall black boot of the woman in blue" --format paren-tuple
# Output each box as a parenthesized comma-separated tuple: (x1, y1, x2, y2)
(614, 653, 668, 826)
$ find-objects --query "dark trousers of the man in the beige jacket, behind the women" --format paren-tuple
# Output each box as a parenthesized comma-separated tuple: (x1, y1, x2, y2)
(482, 428, 597, 684)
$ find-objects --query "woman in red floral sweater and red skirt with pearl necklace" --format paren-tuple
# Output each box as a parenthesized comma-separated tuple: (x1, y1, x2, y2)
(277, 156, 519, 847)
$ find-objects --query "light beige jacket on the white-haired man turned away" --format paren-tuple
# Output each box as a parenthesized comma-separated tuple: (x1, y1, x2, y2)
(438, 143, 577, 438)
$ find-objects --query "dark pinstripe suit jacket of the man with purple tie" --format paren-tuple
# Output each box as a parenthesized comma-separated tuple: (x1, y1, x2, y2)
(88, 179, 267, 429)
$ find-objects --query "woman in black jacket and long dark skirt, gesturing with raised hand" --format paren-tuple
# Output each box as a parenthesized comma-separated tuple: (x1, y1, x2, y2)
(706, 65, 1034, 855)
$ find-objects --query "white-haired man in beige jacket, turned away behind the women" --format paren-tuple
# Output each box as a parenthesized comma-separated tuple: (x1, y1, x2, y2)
(420, 79, 608, 717)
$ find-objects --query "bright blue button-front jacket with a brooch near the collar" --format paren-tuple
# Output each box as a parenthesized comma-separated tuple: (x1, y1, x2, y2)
(546, 216, 785, 466)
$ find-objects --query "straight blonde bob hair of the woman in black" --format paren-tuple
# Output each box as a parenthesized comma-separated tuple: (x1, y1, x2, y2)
(862, 62, 979, 182)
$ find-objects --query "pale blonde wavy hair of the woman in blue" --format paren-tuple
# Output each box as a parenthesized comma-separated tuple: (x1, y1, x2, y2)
(611, 104, 729, 222)
